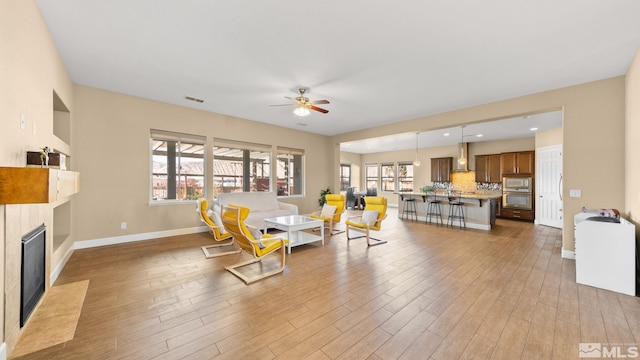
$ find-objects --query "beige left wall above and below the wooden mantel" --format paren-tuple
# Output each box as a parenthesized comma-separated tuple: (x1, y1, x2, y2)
(0, 0, 74, 353)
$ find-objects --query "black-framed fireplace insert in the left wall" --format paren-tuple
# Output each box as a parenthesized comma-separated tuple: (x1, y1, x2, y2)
(20, 224, 45, 327)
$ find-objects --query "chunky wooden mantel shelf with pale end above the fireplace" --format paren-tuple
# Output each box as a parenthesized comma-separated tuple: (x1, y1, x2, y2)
(0, 167, 80, 205)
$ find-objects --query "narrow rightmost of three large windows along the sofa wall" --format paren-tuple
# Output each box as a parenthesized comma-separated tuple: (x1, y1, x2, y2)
(276, 147, 304, 196)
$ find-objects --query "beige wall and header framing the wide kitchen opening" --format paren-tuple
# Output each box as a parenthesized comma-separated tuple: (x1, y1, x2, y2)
(334, 76, 635, 251)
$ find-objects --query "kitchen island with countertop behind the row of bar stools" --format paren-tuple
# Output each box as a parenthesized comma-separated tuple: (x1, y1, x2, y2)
(398, 190, 502, 230)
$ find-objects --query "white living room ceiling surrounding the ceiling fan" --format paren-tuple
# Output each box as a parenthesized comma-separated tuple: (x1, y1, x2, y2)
(37, 0, 640, 145)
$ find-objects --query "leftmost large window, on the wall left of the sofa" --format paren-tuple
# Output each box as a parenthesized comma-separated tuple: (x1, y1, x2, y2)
(150, 130, 206, 201)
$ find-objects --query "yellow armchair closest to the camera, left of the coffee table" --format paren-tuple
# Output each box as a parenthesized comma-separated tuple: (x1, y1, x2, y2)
(222, 204, 289, 284)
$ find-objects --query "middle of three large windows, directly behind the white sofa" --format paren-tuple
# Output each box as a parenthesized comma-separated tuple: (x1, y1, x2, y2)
(213, 139, 271, 196)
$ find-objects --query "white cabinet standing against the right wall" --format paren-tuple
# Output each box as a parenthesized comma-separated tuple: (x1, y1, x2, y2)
(574, 213, 636, 296)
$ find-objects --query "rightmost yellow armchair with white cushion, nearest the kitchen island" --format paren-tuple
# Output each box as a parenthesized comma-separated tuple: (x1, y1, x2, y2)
(346, 196, 387, 246)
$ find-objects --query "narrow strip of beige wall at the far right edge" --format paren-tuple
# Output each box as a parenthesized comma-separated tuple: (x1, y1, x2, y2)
(624, 50, 640, 230)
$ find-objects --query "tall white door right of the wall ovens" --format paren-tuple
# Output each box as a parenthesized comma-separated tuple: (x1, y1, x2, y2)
(536, 145, 562, 229)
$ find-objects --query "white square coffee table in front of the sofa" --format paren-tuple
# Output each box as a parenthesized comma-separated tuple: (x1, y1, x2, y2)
(264, 215, 324, 254)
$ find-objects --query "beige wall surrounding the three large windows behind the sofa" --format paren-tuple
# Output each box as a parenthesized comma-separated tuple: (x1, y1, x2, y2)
(72, 86, 337, 240)
